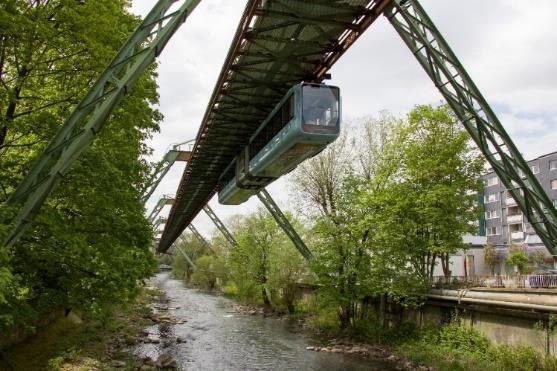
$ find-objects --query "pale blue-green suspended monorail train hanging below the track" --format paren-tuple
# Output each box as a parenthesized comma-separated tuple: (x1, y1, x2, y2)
(219, 83, 340, 205)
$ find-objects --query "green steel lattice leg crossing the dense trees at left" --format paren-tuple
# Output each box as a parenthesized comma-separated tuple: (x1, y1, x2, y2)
(3, 0, 200, 247)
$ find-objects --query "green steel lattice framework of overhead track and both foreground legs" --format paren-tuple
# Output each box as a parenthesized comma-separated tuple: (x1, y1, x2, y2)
(4, 0, 557, 262)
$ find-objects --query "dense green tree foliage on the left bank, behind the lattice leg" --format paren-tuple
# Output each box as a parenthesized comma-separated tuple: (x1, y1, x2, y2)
(0, 0, 161, 328)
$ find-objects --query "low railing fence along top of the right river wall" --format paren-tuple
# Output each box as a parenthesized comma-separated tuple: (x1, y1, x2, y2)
(433, 274, 557, 289)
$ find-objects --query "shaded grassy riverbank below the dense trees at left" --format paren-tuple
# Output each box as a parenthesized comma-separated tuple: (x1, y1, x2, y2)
(0, 288, 160, 371)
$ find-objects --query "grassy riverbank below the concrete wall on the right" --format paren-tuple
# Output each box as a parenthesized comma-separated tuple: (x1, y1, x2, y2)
(222, 292, 557, 371)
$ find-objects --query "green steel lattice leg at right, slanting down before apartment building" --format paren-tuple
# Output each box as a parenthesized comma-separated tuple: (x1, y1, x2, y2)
(384, 0, 557, 257)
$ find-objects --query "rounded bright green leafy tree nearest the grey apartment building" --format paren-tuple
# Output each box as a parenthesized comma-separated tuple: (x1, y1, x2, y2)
(370, 106, 483, 282)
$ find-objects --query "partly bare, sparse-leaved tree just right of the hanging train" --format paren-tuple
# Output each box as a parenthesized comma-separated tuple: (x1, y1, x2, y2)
(293, 114, 404, 329)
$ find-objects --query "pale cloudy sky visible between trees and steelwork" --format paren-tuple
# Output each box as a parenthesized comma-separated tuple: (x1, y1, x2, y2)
(131, 0, 557, 237)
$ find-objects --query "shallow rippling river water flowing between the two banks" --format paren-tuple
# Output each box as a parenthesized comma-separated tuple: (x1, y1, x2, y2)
(136, 273, 394, 370)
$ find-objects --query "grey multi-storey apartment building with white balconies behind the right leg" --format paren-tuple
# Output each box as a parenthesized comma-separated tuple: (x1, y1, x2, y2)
(484, 152, 557, 250)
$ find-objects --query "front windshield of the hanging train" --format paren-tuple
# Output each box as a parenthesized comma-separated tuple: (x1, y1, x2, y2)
(302, 85, 339, 133)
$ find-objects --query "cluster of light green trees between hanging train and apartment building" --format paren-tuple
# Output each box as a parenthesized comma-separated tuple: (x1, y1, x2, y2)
(294, 106, 483, 328)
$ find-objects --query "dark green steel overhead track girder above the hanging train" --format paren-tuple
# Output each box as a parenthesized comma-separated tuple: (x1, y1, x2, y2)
(158, 0, 389, 251)
